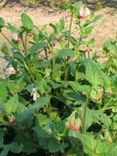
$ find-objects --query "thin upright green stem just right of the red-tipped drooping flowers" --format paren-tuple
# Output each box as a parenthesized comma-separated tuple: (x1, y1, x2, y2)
(82, 96, 89, 133)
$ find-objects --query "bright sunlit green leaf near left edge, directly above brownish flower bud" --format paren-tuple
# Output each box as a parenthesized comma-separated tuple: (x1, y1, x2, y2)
(4, 95, 19, 114)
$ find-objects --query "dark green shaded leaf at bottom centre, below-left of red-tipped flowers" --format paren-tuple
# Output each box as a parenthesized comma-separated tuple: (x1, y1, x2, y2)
(48, 137, 67, 153)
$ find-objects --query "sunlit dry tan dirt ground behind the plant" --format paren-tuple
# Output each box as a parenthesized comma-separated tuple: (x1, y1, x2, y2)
(0, 4, 117, 76)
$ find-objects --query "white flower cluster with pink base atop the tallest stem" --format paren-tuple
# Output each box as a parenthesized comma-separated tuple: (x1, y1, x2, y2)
(79, 7, 91, 19)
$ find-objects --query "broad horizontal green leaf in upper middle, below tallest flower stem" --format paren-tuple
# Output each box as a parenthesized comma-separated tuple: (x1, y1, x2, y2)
(56, 48, 75, 58)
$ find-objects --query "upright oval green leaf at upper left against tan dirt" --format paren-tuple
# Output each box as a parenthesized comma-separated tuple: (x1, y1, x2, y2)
(21, 13, 34, 30)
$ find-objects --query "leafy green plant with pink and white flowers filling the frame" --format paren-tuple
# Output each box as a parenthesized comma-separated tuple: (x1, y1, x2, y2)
(0, 2, 117, 156)
